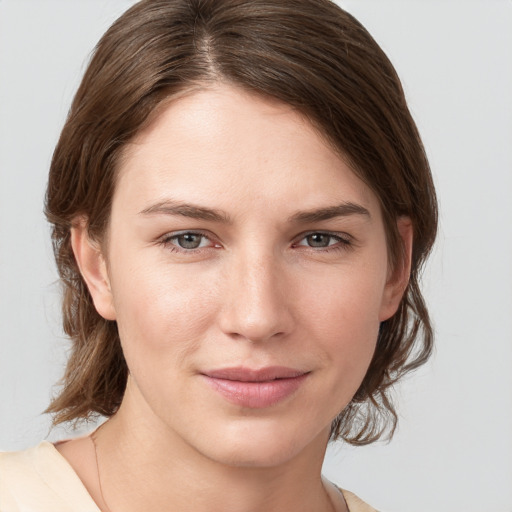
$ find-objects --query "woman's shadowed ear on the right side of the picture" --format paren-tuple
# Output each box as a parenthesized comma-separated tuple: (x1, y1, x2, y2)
(379, 216, 414, 322)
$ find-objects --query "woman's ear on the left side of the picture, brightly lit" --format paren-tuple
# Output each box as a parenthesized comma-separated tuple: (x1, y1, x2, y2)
(71, 219, 116, 320)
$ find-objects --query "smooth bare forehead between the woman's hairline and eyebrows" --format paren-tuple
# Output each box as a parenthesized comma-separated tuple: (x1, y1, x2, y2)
(114, 85, 376, 217)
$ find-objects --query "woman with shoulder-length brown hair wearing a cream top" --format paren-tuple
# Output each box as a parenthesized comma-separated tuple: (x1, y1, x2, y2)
(0, 0, 437, 512)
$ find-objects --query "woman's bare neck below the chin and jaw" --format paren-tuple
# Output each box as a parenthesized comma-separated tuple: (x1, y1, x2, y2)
(96, 384, 341, 512)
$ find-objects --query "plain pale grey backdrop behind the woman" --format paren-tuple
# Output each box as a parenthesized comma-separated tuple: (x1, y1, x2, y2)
(0, 0, 512, 512)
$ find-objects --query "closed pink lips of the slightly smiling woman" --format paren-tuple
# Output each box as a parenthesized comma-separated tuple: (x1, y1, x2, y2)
(203, 366, 309, 409)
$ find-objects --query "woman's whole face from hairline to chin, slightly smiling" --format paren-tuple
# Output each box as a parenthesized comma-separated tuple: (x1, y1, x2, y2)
(83, 85, 408, 466)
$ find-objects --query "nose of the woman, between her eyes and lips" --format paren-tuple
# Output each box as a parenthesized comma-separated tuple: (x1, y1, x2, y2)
(219, 246, 294, 342)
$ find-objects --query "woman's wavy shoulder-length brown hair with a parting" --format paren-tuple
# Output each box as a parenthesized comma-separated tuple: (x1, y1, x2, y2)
(46, 0, 437, 444)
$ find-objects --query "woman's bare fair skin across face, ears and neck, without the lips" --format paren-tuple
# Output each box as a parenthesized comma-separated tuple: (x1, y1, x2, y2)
(58, 84, 412, 512)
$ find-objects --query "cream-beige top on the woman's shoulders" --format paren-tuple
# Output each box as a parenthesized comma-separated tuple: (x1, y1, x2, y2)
(0, 441, 376, 512)
